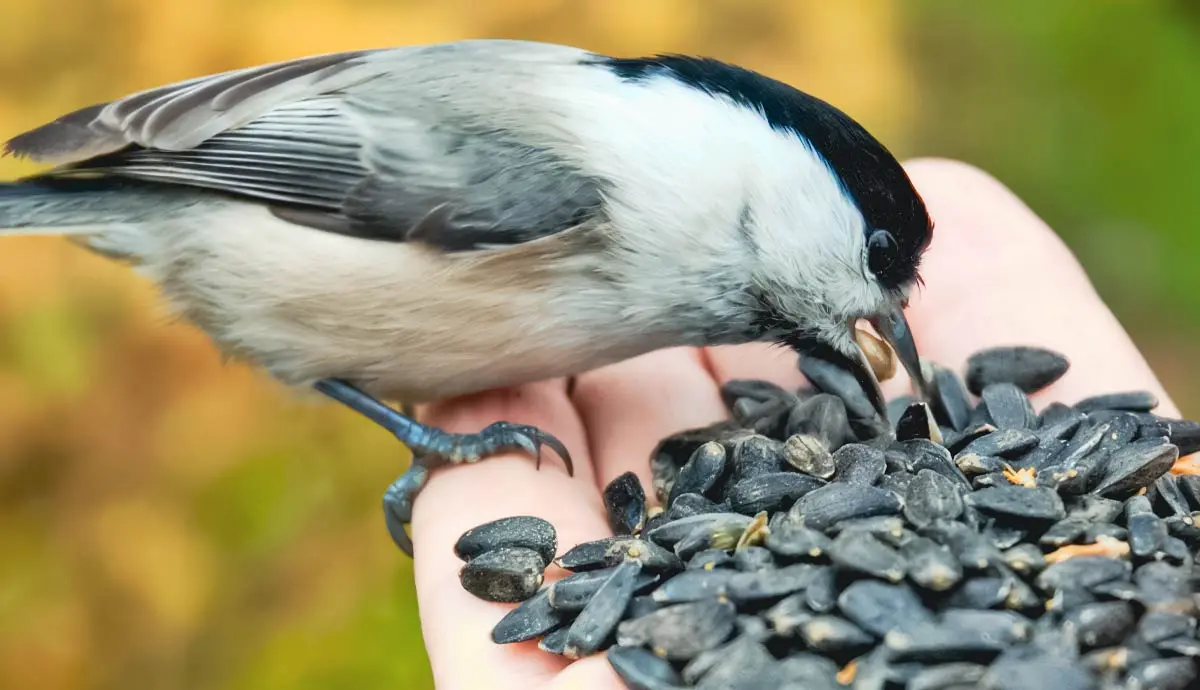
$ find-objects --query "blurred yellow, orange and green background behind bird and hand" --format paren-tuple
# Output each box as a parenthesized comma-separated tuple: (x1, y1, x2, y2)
(0, 0, 1200, 690)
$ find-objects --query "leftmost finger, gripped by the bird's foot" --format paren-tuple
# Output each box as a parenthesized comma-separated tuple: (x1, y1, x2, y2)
(413, 382, 607, 689)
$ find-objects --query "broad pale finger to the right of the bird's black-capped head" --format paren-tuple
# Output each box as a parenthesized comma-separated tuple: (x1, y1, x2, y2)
(906, 160, 1178, 414)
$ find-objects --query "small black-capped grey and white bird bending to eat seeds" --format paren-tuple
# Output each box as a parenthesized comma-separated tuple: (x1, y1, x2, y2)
(0, 40, 932, 554)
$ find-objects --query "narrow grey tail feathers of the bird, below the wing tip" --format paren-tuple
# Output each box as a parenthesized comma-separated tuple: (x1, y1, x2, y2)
(0, 178, 194, 235)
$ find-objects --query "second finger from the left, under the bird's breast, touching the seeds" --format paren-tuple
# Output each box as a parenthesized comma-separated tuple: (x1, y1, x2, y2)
(571, 348, 726, 496)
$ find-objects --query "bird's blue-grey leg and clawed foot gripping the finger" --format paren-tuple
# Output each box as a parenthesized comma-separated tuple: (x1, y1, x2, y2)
(314, 379, 575, 556)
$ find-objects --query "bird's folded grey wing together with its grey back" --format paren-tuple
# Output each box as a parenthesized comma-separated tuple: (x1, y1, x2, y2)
(6, 41, 604, 250)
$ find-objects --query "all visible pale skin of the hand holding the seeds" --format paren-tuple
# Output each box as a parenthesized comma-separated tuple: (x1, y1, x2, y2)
(412, 160, 1178, 690)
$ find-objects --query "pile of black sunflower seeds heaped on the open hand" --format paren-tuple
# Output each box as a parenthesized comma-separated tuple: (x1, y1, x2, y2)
(456, 347, 1200, 690)
